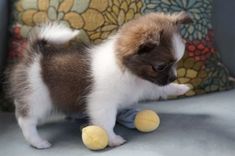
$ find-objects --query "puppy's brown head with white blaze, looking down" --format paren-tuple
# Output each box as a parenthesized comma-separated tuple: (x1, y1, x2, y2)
(116, 12, 192, 86)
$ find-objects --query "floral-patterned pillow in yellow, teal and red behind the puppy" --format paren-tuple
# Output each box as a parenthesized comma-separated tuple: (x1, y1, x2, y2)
(9, 0, 235, 99)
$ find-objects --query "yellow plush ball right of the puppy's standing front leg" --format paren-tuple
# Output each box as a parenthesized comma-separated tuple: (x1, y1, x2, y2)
(134, 110, 160, 132)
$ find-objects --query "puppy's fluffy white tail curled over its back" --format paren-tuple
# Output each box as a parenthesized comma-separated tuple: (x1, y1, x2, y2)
(29, 23, 79, 46)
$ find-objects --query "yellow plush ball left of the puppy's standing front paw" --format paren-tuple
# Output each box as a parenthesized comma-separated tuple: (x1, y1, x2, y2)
(82, 126, 108, 150)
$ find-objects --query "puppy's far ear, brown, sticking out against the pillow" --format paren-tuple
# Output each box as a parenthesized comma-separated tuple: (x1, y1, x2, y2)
(172, 11, 193, 25)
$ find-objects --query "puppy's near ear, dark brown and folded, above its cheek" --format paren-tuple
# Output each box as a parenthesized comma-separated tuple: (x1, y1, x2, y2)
(137, 30, 163, 54)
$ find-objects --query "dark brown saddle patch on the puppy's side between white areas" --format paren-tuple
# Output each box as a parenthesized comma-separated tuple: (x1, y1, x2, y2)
(41, 42, 91, 112)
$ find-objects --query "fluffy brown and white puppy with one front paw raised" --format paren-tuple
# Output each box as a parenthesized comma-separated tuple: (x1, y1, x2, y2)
(9, 13, 191, 149)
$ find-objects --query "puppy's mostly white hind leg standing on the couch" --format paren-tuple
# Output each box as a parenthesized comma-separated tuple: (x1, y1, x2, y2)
(13, 56, 52, 149)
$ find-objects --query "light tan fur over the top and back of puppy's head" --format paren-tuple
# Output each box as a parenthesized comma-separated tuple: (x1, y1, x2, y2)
(116, 13, 190, 59)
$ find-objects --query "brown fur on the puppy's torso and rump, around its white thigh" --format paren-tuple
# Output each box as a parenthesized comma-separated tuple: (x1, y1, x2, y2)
(6, 40, 91, 117)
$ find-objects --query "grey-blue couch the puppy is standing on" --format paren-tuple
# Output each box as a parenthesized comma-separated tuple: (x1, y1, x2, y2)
(0, 0, 235, 156)
